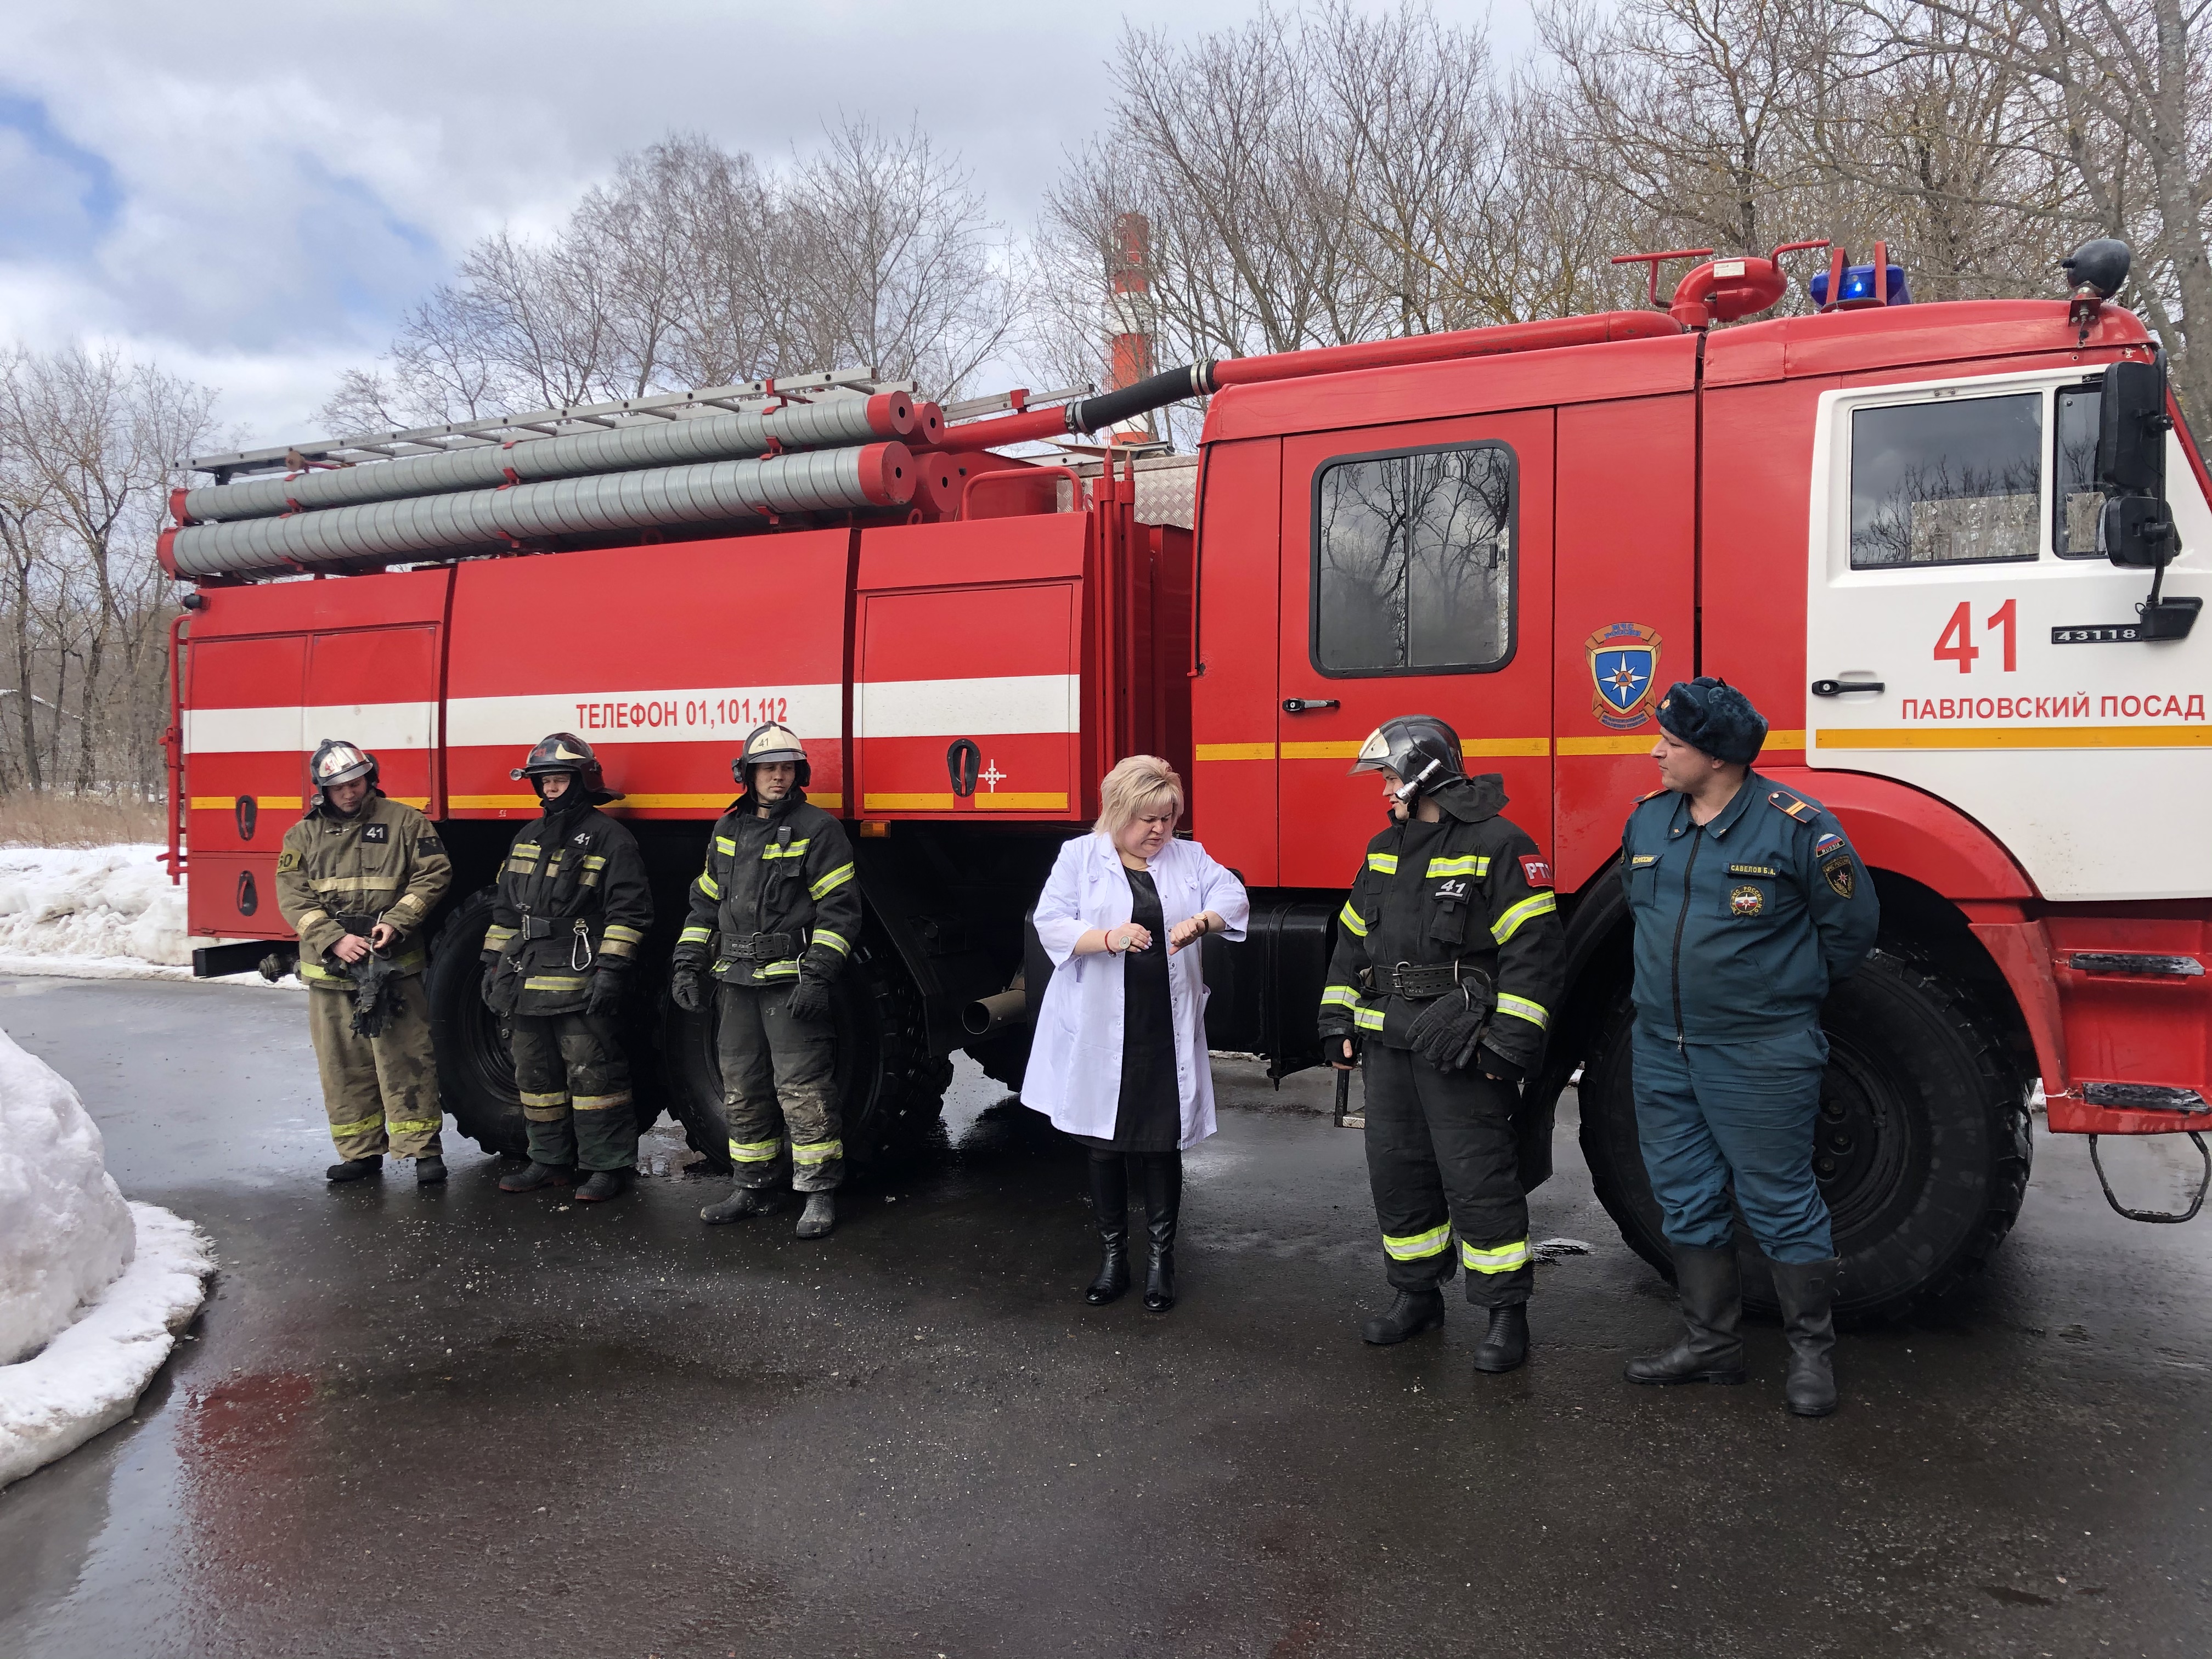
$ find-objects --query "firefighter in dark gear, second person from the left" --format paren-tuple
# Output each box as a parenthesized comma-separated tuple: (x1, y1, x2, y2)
(484, 732, 652, 1203)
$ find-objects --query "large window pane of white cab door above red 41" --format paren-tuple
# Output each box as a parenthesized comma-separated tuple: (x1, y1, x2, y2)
(1852, 392, 2044, 571)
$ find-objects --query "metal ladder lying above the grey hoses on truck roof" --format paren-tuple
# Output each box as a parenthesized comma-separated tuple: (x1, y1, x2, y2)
(179, 369, 918, 484)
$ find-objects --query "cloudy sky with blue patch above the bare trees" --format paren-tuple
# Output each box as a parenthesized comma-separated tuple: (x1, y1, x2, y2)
(0, 0, 1531, 455)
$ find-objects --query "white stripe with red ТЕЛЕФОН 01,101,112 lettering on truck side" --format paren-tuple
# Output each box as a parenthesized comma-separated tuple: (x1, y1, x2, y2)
(444, 681, 845, 748)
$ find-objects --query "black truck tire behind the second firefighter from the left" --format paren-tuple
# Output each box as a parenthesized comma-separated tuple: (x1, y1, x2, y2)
(422, 887, 664, 1157)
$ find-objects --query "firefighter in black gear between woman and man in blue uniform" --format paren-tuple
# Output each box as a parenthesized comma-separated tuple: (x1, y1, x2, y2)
(1321, 714, 1566, 1372)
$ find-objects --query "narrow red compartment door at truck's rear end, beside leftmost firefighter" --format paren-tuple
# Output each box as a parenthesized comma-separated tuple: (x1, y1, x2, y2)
(184, 635, 307, 938)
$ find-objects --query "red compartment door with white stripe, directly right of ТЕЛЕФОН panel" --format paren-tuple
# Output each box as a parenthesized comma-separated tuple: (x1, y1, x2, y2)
(851, 513, 1091, 823)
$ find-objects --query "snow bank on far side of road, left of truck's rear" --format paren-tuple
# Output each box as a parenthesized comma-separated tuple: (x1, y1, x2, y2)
(0, 843, 193, 973)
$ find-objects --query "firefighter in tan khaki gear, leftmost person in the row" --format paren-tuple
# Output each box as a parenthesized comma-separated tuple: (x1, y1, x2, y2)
(276, 739, 454, 1186)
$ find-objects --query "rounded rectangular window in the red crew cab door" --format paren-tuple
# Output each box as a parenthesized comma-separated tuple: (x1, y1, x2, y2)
(1312, 442, 1513, 675)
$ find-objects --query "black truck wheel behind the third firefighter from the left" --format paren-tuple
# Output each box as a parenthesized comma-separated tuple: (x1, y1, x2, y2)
(662, 929, 953, 1170)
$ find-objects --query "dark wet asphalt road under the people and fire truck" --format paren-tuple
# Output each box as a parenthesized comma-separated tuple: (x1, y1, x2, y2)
(0, 980, 2212, 1659)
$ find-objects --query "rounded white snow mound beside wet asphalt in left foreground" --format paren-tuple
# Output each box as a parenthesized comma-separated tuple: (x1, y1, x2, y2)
(0, 1033, 215, 1487)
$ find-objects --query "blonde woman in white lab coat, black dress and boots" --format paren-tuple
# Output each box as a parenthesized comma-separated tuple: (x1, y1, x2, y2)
(1022, 754, 1252, 1314)
